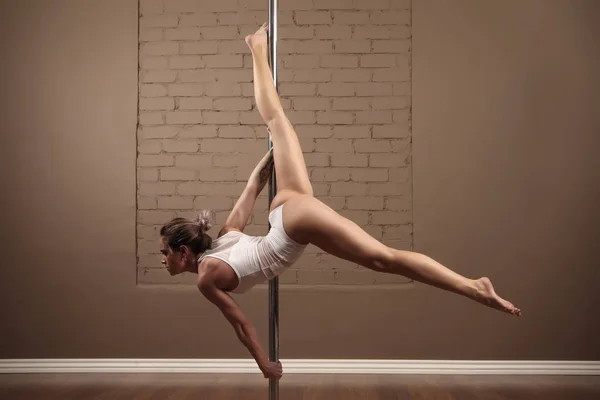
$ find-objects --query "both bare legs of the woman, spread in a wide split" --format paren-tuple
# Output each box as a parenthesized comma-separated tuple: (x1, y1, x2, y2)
(246, 25, 521, 315)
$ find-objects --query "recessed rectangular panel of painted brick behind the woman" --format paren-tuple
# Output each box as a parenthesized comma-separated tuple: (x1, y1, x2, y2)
(137, 0, 412, 285)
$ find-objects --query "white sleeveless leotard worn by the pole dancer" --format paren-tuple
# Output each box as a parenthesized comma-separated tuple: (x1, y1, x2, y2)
(198, 204, 307, 293)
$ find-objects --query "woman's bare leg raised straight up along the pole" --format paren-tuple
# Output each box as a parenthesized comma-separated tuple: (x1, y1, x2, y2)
(246, 24, 313, 208)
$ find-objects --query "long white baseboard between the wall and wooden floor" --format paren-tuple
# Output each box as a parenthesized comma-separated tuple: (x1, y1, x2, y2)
(0, 359, 600, 375)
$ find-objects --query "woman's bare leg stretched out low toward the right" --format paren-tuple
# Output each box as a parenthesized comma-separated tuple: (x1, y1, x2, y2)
(284, 198, 521, 315)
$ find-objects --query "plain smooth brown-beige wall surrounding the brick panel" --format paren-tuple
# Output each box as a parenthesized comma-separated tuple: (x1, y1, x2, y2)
(0, 0, 600, 360)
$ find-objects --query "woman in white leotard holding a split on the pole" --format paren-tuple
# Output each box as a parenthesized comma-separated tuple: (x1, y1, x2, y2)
(160, 24, 521, 379)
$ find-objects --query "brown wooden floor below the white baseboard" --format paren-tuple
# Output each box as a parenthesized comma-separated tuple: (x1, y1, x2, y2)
(0, 374, 600, 400)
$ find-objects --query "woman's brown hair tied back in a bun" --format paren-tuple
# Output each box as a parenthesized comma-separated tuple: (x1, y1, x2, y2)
(160, 210, 214, 254)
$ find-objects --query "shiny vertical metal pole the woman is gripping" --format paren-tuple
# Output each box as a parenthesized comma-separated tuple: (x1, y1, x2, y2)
(268, 0, 279, 400)
